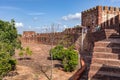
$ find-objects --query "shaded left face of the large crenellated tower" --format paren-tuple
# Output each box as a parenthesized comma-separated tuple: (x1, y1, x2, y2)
(82, 6, 101, 27)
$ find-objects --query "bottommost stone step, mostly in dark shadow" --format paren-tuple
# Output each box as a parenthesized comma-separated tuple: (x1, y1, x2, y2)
(88, 71, 120, 80)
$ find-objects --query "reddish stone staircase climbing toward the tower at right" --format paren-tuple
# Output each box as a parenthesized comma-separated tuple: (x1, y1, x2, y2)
(87, 29, 120, 80)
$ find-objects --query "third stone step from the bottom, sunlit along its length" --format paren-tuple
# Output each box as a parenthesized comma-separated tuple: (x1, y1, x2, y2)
(92, 58, 120, 66)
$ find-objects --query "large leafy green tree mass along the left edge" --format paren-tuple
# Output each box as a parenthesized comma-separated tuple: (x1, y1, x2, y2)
(0, 19, 21, 79)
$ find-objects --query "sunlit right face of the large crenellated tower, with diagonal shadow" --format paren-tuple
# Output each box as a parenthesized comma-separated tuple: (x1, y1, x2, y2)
(101, 6, 120, 28)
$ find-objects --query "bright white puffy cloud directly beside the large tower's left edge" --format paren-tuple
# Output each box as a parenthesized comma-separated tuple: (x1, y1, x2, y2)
(62, 13, 81, 21)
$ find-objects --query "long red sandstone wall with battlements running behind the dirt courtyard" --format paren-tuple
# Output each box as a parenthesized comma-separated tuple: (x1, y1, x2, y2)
(22, 27, 82, 47)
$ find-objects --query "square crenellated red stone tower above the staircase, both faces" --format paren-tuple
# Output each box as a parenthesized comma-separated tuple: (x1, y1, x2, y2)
(82, 6, 120, 28)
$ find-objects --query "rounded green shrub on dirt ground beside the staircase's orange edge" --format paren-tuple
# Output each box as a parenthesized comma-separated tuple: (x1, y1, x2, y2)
(50, 45, 78, 72)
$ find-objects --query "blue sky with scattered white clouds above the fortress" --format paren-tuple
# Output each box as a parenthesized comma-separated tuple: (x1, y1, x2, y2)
(0, 0, 120, 34)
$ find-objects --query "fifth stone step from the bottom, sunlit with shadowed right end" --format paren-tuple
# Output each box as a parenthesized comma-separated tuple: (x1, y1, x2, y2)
(94, 47, 120, 53)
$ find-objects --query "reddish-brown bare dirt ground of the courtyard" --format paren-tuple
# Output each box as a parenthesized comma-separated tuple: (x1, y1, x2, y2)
(4, 44, 75, 80)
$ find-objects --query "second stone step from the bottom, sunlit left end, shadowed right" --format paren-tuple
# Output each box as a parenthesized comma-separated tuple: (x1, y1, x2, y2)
(90, 64, 120, 74)
